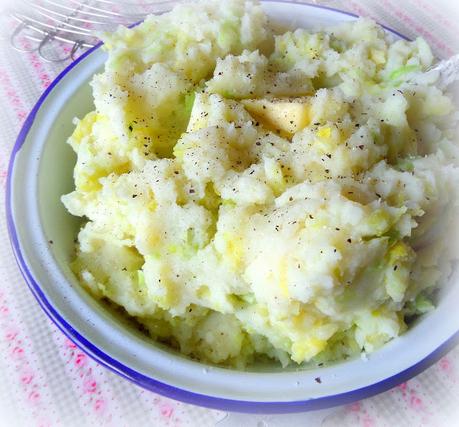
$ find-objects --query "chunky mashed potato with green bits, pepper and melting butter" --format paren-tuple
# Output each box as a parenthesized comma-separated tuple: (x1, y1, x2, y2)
(62, 0, 459, 367)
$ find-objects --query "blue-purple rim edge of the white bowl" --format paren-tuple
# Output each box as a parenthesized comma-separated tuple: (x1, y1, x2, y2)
(6, 0, 459, 414)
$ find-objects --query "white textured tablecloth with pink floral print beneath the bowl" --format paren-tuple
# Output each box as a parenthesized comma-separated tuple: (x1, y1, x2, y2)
(0, 0, 459, 427)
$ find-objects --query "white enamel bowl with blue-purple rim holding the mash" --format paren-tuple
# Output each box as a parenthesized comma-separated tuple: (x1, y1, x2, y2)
(7, 1, 459, 413)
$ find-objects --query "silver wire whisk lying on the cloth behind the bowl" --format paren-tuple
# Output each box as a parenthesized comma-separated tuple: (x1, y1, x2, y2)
(7, 0, 177, 62)
